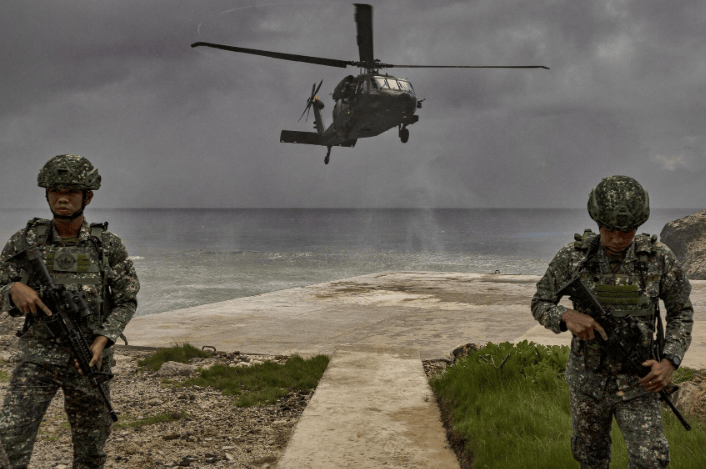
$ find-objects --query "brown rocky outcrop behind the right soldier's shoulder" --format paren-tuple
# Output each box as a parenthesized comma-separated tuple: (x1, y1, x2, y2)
(659, 211, 706, 280)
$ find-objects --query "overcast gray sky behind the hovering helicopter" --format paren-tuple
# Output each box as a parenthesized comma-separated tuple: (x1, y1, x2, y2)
(0, 0, 706, 209)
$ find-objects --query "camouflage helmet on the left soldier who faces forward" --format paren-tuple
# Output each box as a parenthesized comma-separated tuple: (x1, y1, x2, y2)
(37, 155, 101, 191)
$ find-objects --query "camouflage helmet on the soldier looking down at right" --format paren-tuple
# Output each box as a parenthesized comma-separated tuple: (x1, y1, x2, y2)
(588, 176, 650, 231)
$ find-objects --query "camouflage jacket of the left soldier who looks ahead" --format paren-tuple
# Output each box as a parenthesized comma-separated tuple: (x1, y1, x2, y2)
(0, 220, 140, 365)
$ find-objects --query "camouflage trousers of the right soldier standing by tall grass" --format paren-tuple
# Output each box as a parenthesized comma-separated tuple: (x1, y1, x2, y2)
(570, 380, 669, 469)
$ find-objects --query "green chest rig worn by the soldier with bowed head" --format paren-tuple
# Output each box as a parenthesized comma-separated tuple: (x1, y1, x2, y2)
(574, 230, 664, 371)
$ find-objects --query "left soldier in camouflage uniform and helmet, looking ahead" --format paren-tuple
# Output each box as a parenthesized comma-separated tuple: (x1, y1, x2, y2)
(0, 155, 140, 469)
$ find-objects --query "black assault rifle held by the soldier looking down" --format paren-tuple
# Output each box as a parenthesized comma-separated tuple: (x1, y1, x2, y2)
(556, 277, 691, 431)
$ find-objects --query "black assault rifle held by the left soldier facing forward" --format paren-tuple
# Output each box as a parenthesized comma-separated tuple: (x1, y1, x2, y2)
(10, 247, 118, 422)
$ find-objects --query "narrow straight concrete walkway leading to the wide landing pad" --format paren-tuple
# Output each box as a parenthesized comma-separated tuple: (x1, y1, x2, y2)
(277, 345, 459, 469)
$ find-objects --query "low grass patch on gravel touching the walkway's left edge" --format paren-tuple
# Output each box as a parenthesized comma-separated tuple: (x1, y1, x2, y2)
(182, 355, 329, 407)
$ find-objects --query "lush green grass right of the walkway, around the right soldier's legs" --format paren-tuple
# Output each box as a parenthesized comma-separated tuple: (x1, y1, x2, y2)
(430, 341, 706, 469)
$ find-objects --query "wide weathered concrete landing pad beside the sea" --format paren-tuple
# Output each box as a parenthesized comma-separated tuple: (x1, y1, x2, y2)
(125, 272, 706, 368)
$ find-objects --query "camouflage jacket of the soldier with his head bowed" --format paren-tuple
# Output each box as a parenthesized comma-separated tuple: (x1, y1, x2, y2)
(532, 231, 694, 399)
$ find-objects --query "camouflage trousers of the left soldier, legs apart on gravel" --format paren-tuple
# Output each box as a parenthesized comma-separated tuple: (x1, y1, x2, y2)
(0, 362, 112, 469)
